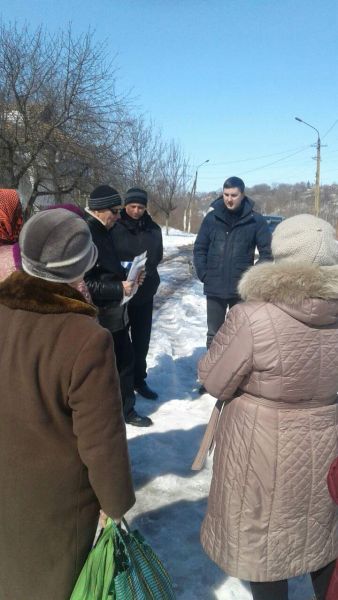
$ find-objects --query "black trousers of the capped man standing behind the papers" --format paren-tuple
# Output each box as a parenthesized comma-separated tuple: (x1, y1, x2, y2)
(128, 298, 153, 387)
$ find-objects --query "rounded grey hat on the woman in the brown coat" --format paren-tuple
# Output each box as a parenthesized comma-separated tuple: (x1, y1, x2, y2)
(19, 208, 97, 283)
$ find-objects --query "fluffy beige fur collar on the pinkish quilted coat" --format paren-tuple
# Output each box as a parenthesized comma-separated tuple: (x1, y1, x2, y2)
(238, 260, 338, 305)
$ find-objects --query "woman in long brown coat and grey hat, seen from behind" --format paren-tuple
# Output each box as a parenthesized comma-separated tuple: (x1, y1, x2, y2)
(0, 209, 135, 600)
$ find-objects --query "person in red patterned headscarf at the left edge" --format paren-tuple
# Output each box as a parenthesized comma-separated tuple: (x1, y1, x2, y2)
(0, 189, 23, 281)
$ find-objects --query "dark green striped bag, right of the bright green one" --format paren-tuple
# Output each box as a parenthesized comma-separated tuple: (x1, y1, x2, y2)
(111, 519, 176, 600)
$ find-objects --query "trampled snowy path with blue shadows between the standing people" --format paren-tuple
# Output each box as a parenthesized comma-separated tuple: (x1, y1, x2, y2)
(127, 230, 313, 600)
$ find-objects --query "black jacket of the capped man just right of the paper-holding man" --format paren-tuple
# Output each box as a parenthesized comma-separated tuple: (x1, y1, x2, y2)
(111, 209, 163, 306)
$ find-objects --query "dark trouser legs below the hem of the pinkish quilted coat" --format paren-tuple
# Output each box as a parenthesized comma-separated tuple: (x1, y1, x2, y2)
(250, 561, 336, 600)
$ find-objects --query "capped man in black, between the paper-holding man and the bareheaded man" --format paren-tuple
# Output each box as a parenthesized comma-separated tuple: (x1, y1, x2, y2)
(111, 187, 163, 400)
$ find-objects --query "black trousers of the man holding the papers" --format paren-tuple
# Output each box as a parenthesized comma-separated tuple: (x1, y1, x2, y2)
(111, 327, 135, 418)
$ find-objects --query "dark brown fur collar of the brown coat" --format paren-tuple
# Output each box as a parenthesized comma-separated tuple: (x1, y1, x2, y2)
(0, 271, 97, 317)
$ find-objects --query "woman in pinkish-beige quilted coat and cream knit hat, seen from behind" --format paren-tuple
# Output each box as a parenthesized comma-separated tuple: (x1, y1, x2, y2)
(193, 215, 338, 600)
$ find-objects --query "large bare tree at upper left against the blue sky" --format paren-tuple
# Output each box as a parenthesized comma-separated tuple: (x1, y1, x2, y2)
(0, 25, 131, 216)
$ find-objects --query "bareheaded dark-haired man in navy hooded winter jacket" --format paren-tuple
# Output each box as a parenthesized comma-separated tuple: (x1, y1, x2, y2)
(194, 177, 272, 348)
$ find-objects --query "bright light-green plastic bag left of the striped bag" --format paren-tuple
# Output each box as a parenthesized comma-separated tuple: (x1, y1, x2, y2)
(70, 519, 115, 600)
